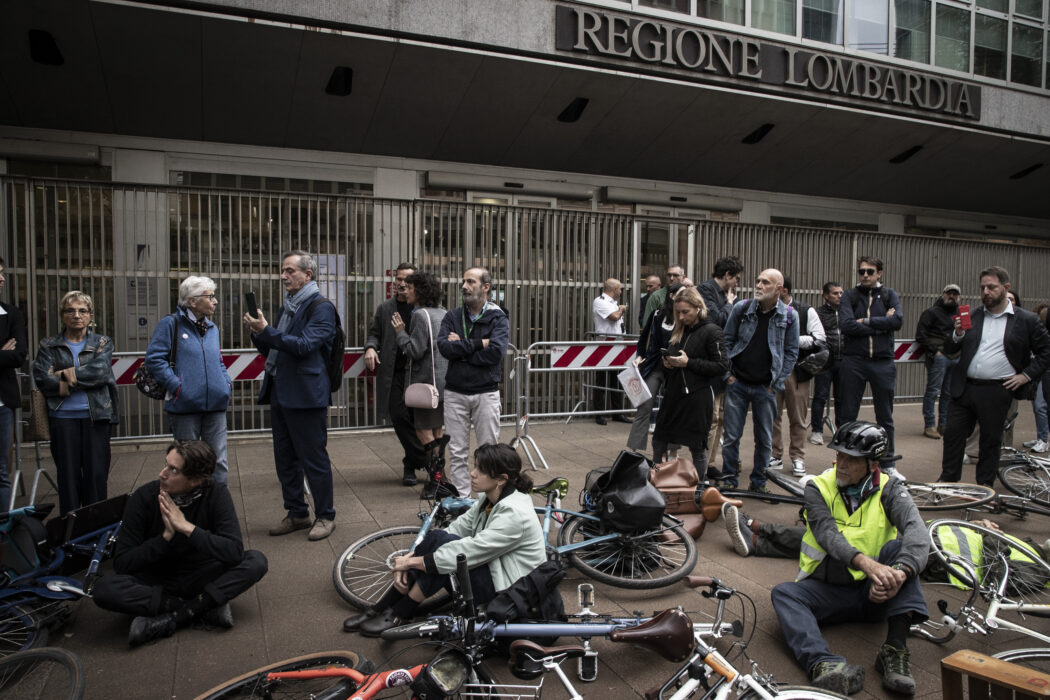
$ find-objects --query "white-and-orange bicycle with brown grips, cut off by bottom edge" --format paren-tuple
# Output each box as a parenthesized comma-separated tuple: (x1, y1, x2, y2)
(646, 576, 845, 700)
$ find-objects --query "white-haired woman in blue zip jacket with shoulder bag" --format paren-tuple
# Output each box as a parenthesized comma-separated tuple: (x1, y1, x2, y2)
(146, 277, 230, 484)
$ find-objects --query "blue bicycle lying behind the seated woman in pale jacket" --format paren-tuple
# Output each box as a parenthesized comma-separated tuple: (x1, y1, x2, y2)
(332, 479, 697, 614)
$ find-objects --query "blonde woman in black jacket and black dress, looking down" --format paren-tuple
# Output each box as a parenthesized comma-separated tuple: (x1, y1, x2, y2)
(653, 287, 729, 481)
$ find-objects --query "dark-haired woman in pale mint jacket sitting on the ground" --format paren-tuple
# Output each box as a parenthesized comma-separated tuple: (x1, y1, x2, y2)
(342, 444, 547, 637)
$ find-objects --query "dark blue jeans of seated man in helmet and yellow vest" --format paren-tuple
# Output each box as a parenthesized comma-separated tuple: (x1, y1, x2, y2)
(770, 539, 929, 674)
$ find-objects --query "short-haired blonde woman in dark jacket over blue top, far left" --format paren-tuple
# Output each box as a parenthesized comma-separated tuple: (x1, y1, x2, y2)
(33, 291, 120, 513)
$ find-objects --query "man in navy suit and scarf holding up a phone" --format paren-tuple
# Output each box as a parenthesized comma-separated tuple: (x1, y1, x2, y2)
(244, 251, 336, 540)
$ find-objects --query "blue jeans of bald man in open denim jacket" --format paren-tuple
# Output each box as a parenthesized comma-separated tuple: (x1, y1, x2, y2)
(722, 380, 777, 488)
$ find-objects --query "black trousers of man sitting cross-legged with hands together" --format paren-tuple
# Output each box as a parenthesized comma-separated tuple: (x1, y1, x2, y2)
(91, 549, 269, 617)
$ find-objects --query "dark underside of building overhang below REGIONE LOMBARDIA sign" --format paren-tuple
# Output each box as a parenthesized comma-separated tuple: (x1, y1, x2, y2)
(0, 0, 1050, 219)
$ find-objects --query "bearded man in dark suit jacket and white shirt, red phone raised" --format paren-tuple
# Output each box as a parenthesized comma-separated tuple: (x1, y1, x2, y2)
(938, 266, 1050, 486)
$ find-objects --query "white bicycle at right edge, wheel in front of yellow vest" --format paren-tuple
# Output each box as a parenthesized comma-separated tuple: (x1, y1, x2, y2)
(911, 519, 1050, 673)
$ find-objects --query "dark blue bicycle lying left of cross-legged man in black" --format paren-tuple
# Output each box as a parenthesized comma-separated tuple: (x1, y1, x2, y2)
(0, 495, 127, 657)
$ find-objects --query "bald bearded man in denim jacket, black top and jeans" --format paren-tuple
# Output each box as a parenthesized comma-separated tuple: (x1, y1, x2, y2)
(722, 269, 799, 493)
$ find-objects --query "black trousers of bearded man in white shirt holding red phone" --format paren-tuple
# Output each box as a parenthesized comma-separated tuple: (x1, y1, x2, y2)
(938, 384, 1013, 486)
